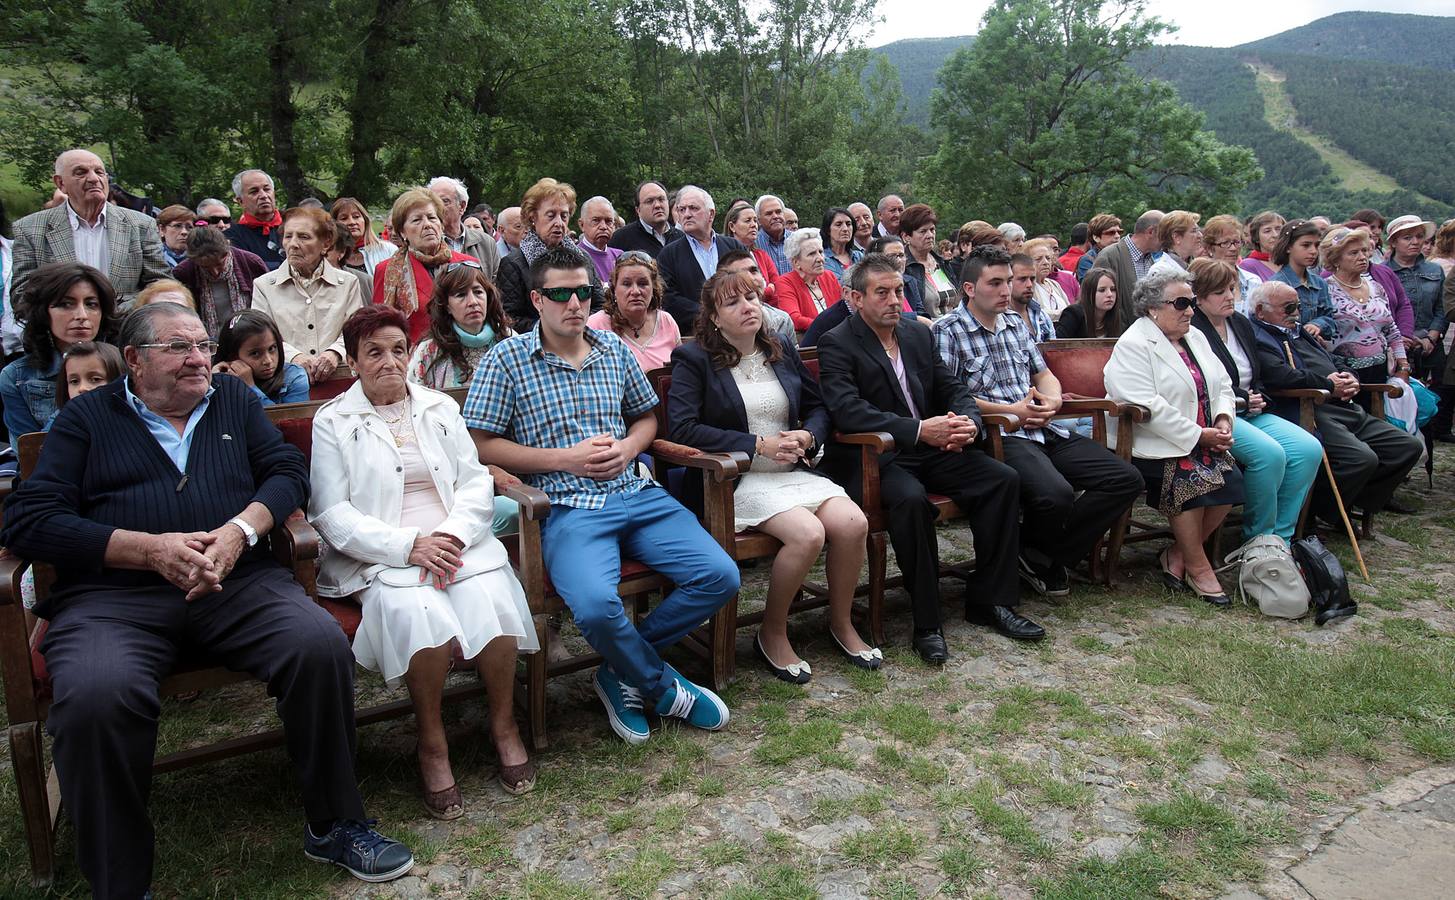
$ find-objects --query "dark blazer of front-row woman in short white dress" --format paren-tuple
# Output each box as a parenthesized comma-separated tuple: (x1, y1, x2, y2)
(666, 342, 829, 507)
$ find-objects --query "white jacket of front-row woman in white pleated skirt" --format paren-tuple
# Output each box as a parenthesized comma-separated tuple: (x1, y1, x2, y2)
(308, 382, 508, 598)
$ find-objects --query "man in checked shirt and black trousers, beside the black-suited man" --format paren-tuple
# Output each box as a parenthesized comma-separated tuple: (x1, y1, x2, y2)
(934, 246, 1142, 596)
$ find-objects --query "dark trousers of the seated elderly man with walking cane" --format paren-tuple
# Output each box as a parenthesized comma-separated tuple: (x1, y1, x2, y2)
(1314, 400, 1424, 522)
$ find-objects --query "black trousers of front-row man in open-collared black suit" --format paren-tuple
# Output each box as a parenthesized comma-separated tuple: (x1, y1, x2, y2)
(847, 446, 1020, 630)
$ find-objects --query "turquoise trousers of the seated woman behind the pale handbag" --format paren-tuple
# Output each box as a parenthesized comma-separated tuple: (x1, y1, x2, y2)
(1232, 413, 1323, 541)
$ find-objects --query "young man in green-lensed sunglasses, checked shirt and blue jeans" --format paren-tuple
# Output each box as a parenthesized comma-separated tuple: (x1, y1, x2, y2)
(464, 247, 738, 743)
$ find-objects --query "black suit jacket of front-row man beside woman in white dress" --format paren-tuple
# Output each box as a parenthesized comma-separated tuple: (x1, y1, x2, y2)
(818, 316, 984, 473)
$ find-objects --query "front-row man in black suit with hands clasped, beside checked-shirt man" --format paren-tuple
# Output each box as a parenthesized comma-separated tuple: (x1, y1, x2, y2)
(818, 253, 1046, 664)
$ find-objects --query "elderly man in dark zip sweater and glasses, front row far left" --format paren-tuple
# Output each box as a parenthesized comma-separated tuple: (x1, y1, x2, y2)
(0, 302, 413, 900)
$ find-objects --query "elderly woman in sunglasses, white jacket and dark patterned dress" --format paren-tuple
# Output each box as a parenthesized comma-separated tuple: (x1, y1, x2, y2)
(1104, 272, 1243, 606)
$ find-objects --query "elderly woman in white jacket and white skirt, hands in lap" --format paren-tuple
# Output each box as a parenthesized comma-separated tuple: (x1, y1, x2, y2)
(308, 305, 538, 819)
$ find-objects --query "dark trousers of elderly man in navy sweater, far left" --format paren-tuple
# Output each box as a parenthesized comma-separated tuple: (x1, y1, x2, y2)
(42, 563, 364, 900)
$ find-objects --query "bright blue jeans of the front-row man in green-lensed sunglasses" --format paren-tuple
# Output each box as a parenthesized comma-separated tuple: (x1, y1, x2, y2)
(541, 486, 738, 702)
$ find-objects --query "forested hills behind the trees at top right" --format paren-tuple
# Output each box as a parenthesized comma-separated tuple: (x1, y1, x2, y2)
(874, 13, 1455, 218)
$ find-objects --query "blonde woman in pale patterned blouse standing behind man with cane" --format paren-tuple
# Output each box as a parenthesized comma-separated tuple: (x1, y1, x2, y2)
(1318, 225, 1410, 395)
